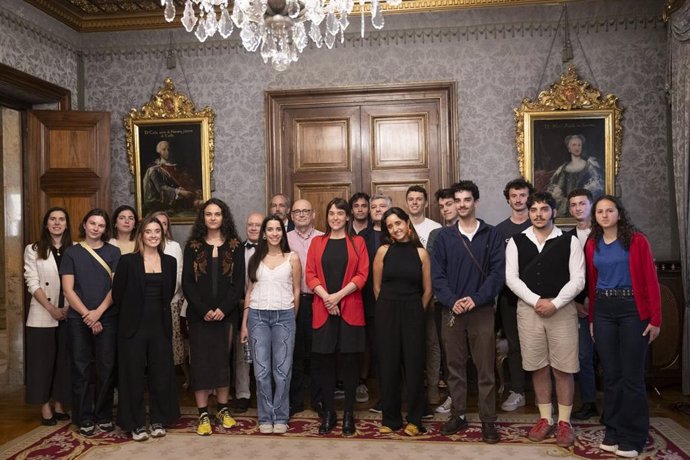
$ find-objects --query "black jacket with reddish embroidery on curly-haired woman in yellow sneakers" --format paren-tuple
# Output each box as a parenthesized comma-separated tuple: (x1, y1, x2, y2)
(182, 239, 244, 324)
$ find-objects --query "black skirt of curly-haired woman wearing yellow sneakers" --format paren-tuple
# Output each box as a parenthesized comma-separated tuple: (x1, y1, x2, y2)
(188, 320, 230, 391)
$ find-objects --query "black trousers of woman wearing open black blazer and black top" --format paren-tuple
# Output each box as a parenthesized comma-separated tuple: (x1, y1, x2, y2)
(117, 306, 180, 431)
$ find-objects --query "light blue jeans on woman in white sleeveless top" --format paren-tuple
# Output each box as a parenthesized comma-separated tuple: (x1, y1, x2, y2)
(247, 308, 296, 425)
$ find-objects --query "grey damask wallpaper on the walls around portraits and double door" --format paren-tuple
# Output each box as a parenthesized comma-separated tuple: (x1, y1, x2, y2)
(0, 0, 677, 259)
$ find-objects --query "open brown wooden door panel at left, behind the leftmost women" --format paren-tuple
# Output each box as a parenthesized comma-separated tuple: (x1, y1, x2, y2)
(24, 110, 111, 241)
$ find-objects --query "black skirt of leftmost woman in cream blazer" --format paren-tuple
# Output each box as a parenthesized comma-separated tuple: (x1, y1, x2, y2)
(26, 321, 72, 404)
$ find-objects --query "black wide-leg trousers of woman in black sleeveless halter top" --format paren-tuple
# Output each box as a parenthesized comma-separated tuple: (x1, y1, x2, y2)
(376, 300, 426, 429)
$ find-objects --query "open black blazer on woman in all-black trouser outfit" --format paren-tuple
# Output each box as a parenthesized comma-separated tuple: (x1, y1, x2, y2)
(113, 254, 177, 338)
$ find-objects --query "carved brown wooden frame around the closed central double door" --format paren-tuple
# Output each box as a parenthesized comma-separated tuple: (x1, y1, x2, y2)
(264, 81, 458, 204)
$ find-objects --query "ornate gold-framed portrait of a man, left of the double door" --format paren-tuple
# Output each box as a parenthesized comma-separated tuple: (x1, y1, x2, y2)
(124, 78, 215, 223)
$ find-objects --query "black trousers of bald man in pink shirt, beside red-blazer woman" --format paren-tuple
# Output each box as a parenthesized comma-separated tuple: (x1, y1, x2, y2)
(290, 294, 321, 409)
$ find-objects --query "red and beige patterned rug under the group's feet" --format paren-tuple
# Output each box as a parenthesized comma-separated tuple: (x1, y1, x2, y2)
(0, 411, 690, 460)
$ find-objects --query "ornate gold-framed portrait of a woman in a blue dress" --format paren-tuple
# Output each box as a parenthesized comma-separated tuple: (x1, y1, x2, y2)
(515, 66, 623, 225)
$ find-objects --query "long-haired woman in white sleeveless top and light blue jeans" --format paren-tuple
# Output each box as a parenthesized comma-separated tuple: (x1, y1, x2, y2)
(241, 215, 302, 434)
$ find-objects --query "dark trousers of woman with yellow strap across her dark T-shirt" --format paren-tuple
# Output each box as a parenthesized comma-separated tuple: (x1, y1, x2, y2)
(67, 317, 117, 426)
